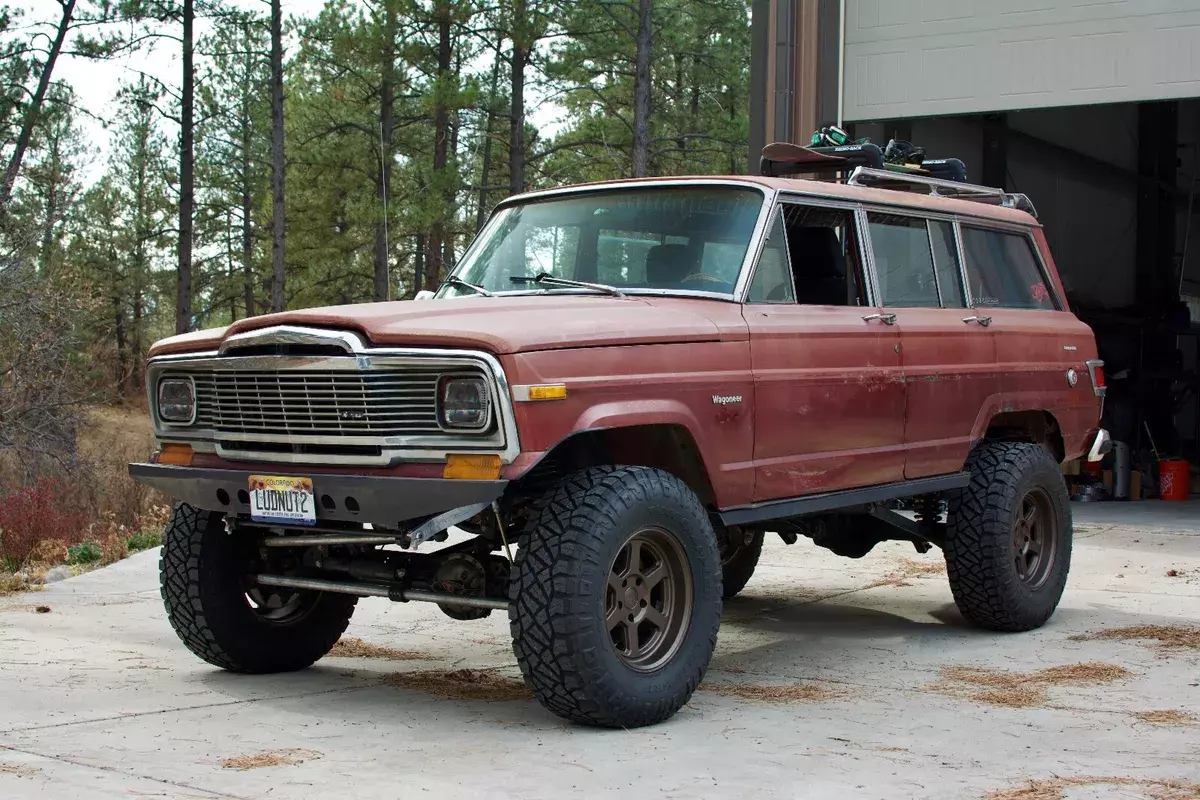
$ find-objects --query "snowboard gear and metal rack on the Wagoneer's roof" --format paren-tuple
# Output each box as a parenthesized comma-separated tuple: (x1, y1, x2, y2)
(758, 137, 1037, 216)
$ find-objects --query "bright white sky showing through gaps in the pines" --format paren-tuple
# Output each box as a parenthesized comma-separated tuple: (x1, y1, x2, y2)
(15, 0, 560, 184)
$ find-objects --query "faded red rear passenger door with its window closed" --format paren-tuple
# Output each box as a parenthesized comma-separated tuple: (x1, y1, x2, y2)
(866, 210, 997, 480)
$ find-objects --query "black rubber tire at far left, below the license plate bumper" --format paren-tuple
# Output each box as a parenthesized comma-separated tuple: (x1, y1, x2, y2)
(158, 503, 358, 674)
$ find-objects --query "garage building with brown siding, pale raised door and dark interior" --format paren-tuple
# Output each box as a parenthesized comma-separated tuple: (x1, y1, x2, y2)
(750, 0, 1200, 482)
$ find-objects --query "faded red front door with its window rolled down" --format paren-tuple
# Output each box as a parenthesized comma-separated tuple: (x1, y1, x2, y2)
(743, 203, 905, 501)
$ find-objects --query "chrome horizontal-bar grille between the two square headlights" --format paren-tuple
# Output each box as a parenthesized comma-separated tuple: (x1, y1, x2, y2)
(176, 369, 479, 438)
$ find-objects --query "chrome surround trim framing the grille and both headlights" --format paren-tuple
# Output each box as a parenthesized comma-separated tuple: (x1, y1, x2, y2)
(146, 325, 521, 467)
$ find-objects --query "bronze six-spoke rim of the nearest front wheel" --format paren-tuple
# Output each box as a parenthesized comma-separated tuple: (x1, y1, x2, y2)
(605, 528, 692, 672)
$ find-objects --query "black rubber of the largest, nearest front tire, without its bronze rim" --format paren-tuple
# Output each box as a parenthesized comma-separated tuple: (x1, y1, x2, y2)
(509, 467, 721, 728)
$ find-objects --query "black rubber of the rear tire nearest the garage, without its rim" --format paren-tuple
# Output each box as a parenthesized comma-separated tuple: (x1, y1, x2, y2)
(944, 441, 1072, 632)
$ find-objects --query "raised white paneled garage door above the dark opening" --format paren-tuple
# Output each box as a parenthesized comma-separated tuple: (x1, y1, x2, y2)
(845, 0, 1200, 121)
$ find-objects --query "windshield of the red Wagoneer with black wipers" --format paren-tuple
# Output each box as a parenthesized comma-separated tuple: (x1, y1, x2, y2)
(438, 186, 763, 297)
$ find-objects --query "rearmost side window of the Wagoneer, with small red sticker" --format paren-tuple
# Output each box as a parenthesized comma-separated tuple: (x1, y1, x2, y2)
(962, 227, 1056, 309)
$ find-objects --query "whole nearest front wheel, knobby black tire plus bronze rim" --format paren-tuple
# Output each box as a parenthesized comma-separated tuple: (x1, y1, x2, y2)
(509, 467, 721, 728)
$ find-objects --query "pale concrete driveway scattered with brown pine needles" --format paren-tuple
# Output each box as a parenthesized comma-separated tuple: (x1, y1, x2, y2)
(0, 503, 1200, 800)
